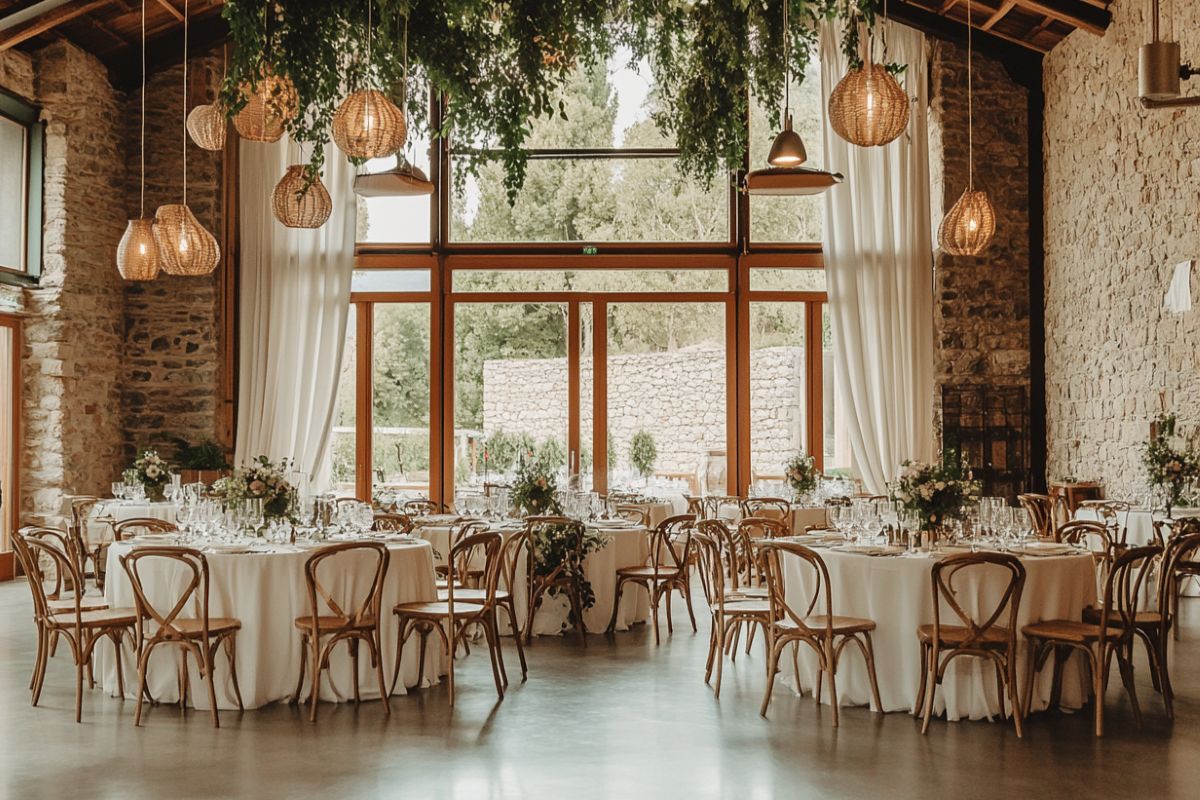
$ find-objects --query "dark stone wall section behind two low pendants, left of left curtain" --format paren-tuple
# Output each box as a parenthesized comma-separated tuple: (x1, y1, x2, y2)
(121, 55, 223, 459)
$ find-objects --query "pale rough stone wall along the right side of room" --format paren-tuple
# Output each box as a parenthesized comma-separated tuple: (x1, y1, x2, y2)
(1044, 0, 1200, 498)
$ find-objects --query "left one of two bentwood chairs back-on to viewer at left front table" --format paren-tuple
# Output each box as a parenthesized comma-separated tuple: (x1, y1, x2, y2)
(121, 546, 245, 728)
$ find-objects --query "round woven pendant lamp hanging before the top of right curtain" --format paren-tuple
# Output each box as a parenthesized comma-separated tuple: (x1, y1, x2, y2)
(829, 64, 908, 148)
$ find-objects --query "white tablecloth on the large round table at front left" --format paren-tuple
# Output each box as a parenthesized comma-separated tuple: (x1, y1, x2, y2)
(96, 541, 443, 709)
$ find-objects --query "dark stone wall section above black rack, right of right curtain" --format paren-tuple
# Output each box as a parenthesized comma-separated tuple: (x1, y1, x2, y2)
(930, 41, 1030, 402)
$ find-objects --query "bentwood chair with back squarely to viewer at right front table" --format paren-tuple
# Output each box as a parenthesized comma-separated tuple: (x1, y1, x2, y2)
(913, 553, 1025, 738)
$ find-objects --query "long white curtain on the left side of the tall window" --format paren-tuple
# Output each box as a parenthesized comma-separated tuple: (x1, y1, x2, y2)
(235, 139, 355, 491)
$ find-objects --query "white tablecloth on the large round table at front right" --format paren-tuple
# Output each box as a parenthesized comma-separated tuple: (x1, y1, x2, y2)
(780, 549, 1096, 720)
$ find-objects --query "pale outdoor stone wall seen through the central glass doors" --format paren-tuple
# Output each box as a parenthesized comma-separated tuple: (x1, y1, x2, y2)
(484, 347, 804, 475)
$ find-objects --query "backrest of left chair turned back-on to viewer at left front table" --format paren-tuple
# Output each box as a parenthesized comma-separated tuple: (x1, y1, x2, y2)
(121, 545, 209, 645)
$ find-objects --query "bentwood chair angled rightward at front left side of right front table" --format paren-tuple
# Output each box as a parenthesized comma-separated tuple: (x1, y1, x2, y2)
(758, 540, 883, 728)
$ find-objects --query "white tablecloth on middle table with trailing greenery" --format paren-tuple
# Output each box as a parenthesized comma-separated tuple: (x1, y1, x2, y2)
(413, 525, 650, 636)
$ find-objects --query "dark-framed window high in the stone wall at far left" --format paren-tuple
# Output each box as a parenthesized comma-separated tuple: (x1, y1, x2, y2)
(0, 92, 42, 279)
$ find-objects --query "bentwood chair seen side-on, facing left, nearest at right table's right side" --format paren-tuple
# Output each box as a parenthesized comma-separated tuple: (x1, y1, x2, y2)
(1021, 545, 1163, 736)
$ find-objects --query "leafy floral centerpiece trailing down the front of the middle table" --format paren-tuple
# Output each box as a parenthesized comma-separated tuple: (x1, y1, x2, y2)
(509, 458, 607, 622)
